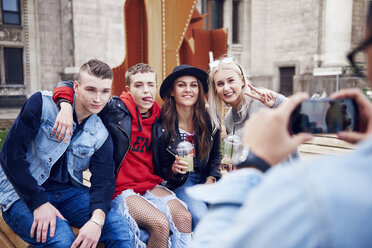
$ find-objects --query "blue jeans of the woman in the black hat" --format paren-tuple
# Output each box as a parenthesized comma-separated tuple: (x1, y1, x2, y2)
(173, 172, 208, 230)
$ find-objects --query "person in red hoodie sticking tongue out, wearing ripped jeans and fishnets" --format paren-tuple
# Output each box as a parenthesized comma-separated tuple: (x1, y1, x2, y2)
(53, 63, 192, 247)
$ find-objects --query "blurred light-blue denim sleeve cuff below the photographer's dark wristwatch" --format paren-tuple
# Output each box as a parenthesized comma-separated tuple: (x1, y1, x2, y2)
(186, 168, 263, 248)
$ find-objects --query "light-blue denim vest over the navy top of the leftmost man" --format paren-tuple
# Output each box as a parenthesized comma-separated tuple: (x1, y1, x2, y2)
(0, 91, 109, 211)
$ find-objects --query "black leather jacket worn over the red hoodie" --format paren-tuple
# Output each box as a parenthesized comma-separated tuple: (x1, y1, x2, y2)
(98, 96, 162, 177)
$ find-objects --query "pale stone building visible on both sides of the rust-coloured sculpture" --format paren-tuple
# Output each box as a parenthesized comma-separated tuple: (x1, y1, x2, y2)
(0, 0, 367, 110)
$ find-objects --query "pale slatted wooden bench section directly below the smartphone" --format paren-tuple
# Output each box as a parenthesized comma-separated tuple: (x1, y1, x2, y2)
(298, 134, 355, 159)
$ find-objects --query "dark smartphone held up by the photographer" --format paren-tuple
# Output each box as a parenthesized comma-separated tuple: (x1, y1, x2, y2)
(289, 98, 359, 134)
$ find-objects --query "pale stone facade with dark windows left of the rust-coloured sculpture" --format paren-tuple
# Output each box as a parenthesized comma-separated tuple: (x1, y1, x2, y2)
(0, 0, 125, 108)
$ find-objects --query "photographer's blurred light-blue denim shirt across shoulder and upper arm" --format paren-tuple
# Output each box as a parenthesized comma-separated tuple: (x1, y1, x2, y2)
(192, 137, 372, 248)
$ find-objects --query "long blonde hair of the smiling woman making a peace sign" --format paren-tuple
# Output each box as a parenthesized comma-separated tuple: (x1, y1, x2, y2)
(208, 56, 251, 134)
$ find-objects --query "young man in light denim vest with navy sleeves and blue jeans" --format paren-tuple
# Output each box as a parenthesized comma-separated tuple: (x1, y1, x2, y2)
(0, 59, 129, 248)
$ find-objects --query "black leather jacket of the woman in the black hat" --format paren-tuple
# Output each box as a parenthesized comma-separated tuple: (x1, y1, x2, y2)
(153, 114, 221, 189)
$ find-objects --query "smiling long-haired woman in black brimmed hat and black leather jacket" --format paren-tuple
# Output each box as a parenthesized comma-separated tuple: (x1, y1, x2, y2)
(157, 65, 221, 228)
